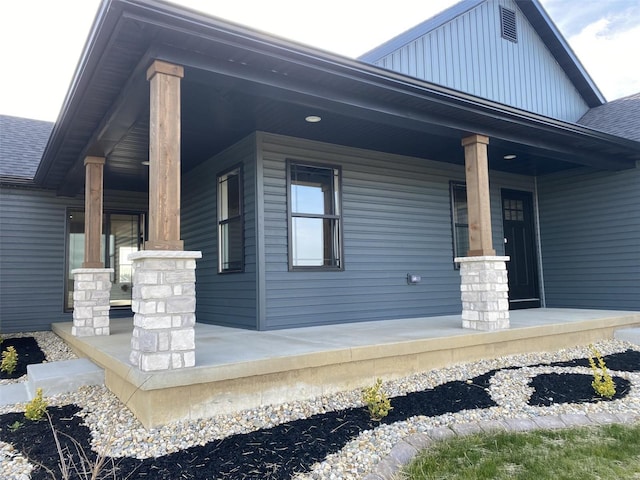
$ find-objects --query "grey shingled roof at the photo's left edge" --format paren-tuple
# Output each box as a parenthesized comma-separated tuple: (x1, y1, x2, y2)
(0, 115, 53, 184)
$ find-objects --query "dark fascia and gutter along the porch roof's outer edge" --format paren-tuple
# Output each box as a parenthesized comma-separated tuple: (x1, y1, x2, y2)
(34, 0, 640, 187)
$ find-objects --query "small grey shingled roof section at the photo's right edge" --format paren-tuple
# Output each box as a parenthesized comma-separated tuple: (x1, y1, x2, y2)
(578, 92, 640, 142)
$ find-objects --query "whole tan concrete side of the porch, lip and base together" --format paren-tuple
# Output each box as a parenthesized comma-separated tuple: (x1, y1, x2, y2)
(53, 312, 640, 427)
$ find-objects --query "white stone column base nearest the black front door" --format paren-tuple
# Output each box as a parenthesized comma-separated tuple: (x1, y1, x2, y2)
(455, 256, 509, 330)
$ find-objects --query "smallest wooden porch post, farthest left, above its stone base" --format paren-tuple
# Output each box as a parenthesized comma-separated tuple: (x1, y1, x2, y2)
(82, 157, 104, 268)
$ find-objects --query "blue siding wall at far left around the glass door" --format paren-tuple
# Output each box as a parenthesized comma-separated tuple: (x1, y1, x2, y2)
(0, 187, 148, 332)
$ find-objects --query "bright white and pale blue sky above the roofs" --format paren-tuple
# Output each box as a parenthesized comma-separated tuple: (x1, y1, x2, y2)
(0, 0, 640, 121)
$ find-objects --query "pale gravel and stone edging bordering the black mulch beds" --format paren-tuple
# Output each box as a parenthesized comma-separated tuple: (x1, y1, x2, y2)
(0, 332, 640, 480)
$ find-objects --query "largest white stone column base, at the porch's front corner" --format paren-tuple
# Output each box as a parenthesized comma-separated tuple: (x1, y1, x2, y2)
(129, 250, 202, 372)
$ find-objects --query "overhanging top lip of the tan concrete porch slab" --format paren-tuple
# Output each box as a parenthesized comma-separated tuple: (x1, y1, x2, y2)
(52, 312, 640, 390)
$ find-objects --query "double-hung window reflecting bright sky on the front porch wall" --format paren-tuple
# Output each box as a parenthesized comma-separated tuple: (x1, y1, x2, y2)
(287, 162, 343, 270)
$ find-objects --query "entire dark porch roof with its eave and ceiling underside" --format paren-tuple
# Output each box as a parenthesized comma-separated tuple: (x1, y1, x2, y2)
(35, 0, 640, 194)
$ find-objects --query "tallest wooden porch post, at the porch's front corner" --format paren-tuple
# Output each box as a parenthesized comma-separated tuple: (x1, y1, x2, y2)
(145, 60, 184, 250)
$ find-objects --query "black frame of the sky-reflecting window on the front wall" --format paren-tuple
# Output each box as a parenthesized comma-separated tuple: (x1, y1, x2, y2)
(286, 159, 344, 272)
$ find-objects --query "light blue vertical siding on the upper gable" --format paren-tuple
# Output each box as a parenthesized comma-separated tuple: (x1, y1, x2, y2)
(374, 0, 588, 122)
